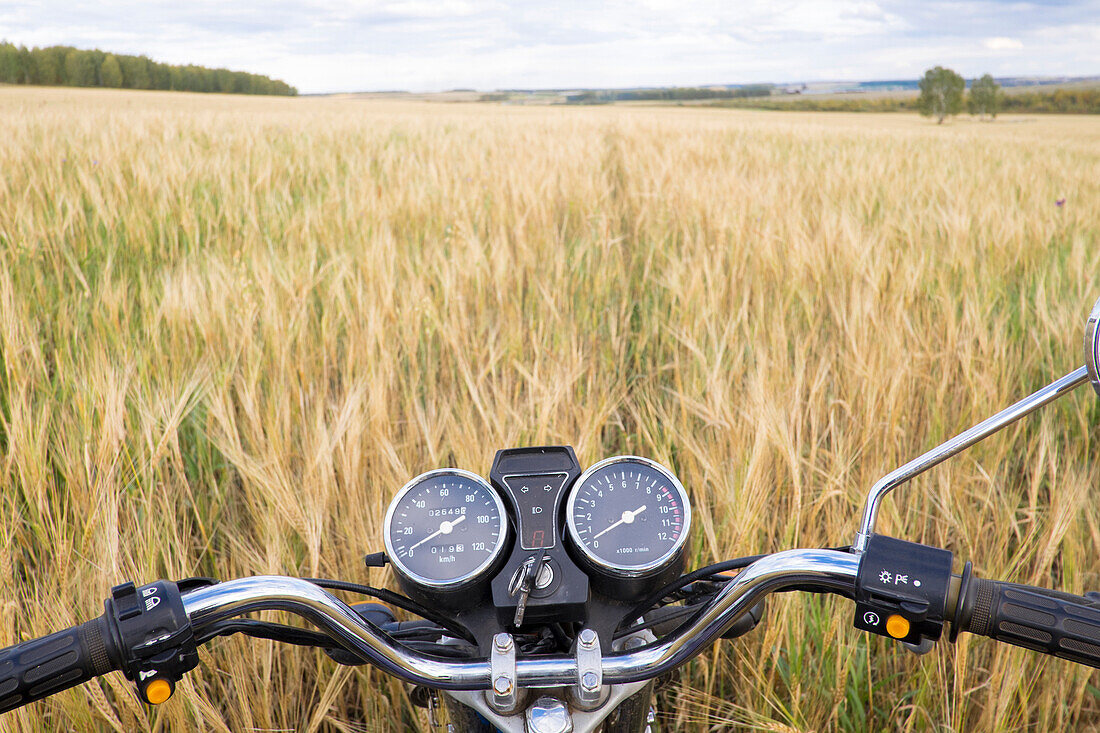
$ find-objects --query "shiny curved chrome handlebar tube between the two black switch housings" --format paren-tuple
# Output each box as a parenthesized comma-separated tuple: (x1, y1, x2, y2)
(183, 549, 860, 690)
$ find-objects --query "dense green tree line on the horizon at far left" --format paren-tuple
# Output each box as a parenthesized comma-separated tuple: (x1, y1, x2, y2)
(0, 43, 298, 97)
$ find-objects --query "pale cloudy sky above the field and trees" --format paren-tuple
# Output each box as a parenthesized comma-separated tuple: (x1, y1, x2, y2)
(0, 0, 1100, 92)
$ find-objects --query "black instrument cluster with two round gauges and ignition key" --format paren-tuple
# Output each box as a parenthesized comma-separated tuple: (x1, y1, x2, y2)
(384, 446, 691, 629)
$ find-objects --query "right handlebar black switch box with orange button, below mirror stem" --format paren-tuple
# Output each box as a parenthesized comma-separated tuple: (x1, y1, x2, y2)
(854, 535, 953, 648)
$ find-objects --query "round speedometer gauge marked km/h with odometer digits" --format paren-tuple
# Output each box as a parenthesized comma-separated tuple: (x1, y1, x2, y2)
(385, 469, 508, 589)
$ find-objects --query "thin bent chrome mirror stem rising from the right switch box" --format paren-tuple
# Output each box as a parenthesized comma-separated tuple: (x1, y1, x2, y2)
(853, 367, 1089, 553)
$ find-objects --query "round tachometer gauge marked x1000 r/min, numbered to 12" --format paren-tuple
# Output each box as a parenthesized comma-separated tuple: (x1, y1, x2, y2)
(565, 456, 691, 576)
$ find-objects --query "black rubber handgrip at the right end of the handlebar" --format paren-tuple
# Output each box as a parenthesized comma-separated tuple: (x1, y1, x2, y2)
(957, 579, 1100, 667)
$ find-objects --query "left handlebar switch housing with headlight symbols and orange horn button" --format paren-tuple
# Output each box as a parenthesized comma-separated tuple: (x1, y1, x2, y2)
(105, 580, 199, 704)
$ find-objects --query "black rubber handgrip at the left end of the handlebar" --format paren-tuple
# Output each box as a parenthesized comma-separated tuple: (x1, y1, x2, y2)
(0, 616, 117, 712)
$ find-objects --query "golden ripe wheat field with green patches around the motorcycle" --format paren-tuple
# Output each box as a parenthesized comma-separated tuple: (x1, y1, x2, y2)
(0, 87, 1100, 733)
